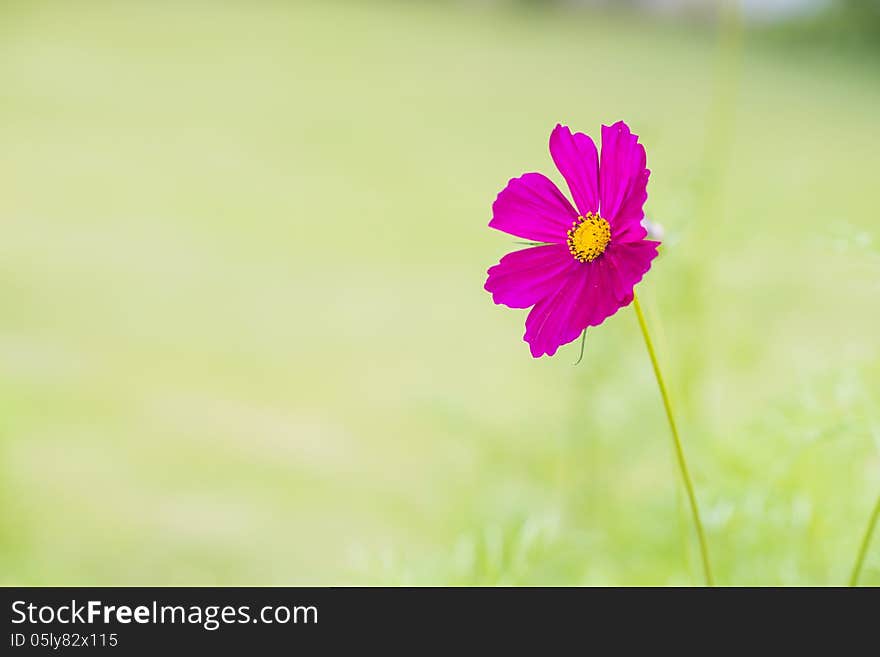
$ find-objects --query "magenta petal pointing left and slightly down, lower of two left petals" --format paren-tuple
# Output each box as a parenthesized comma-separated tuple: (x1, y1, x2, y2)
(485, 244, 580, 308)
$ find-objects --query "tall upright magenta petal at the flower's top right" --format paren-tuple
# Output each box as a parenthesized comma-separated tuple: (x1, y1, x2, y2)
(599, 121, 650, 241)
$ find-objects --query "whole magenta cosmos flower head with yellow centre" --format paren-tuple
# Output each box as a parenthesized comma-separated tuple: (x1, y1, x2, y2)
(485, 121, 660, 358)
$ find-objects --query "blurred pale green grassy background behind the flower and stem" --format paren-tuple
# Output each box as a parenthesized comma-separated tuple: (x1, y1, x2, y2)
(0, 0, 880, 585)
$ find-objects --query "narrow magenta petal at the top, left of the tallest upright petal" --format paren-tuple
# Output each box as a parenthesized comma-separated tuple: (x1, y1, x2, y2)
(550, 124, 599, 215)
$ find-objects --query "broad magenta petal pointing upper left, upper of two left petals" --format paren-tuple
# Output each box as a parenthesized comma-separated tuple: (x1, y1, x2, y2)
(489, 173, 577, 244)
